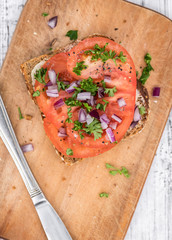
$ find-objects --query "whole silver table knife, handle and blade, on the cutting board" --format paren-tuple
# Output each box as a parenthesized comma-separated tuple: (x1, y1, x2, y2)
(0, 96, 72, 240)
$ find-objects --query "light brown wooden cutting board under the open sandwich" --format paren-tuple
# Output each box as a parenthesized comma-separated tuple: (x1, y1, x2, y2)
(0, 0, 172, 240)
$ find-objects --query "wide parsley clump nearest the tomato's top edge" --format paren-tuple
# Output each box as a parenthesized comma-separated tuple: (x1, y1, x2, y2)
(84, 43, 126, 65)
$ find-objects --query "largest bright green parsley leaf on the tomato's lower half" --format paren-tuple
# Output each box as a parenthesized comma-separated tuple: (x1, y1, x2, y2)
(83, 119, 103, 140)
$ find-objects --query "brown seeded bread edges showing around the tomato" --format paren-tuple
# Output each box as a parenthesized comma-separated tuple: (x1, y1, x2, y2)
(20, 34, 149, 165)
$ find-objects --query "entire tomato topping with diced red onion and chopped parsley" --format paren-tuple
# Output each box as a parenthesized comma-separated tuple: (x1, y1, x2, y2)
(33, 37, 136, 158)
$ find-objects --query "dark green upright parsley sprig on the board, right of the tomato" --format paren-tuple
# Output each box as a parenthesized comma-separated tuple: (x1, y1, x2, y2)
(139, 53, 154, 85)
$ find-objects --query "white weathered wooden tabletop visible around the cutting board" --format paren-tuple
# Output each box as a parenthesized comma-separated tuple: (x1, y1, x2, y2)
(0, 0, 172, 240)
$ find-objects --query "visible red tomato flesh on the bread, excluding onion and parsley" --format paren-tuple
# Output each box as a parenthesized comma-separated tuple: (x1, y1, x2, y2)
(35, 37, 136, 158)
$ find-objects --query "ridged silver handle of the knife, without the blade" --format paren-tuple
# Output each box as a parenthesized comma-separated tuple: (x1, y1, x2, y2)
(0, 96, 42, 198)
